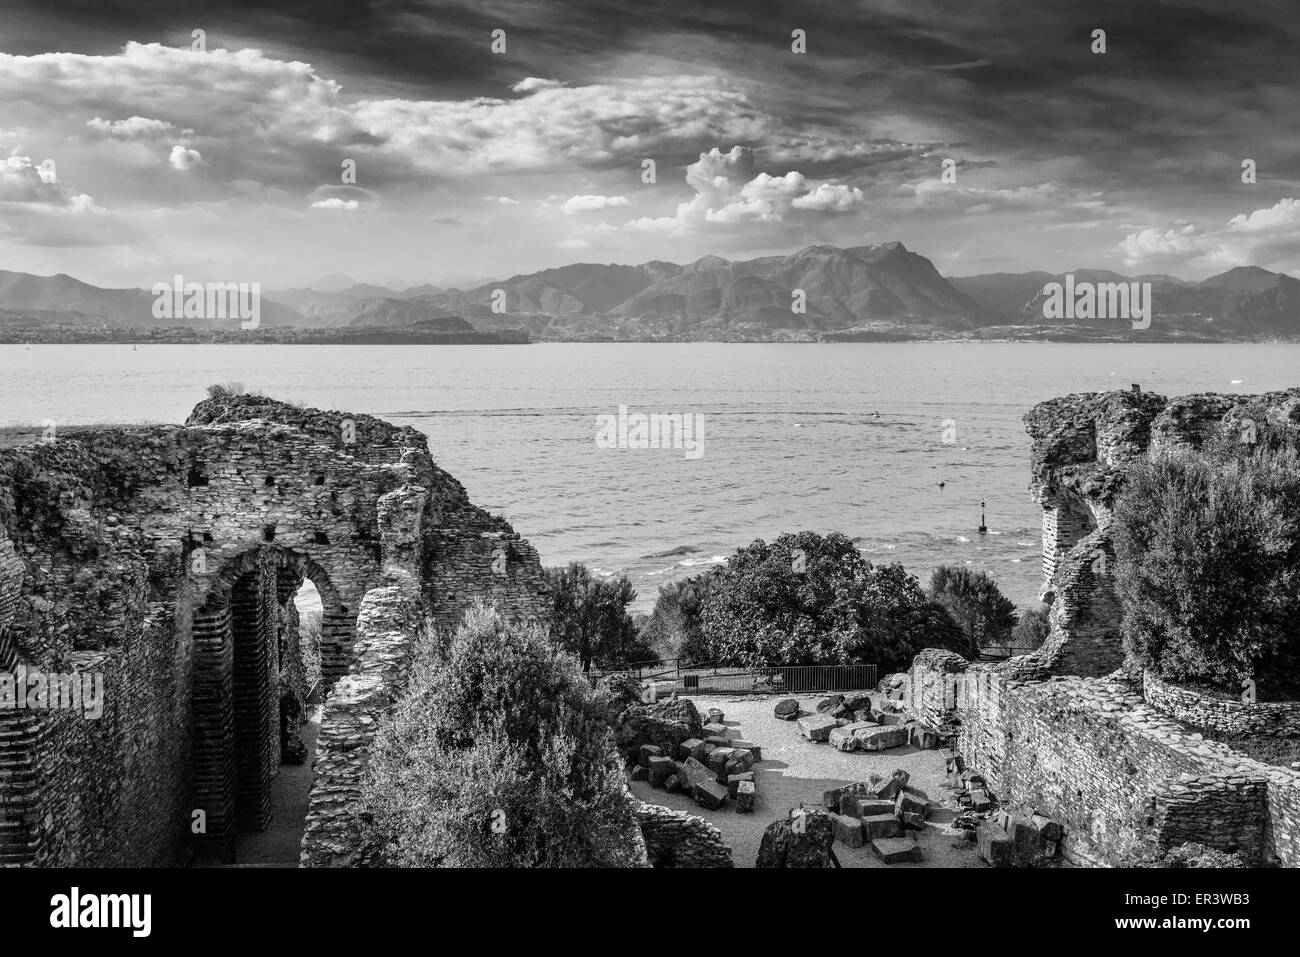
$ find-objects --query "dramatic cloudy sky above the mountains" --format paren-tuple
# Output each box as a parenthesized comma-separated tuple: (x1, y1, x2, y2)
(0, 0, 1300, 289)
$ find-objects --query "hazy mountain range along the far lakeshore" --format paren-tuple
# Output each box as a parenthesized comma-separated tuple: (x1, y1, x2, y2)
(0, 242, 1300, 341)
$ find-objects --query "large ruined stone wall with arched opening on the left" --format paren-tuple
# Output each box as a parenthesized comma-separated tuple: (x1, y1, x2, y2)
(0, 395, 546, 867)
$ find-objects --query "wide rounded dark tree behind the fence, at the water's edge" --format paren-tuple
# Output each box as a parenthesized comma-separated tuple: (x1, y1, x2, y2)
(702, 532, 976, 668)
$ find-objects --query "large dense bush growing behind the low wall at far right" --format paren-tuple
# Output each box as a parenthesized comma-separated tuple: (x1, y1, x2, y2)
(1114, 419, 1300, 697)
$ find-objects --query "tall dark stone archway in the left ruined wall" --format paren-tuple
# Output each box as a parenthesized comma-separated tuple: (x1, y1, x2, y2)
(191, 544, 355, 859)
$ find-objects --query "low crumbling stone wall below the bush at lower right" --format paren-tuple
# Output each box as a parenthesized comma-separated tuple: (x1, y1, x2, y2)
(905, 649, 1300, 866)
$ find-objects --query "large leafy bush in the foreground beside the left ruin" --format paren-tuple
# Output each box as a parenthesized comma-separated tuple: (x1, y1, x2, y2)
(363, 605, 642, 867)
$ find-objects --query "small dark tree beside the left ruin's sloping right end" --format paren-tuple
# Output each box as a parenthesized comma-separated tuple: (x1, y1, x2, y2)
(546, 562, 655, 671)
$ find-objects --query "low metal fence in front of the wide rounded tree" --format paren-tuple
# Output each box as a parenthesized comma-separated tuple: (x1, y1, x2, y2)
(588, 659, 878, 698)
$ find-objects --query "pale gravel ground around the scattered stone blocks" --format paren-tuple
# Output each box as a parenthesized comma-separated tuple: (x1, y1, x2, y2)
(631, 694, 988, 867)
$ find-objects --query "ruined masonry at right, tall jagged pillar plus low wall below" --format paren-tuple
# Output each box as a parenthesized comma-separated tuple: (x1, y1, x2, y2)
(906, 389, 1300, 867)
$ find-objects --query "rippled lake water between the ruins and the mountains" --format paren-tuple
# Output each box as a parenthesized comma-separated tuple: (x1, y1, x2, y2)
(0, 343, 1300, 610)
